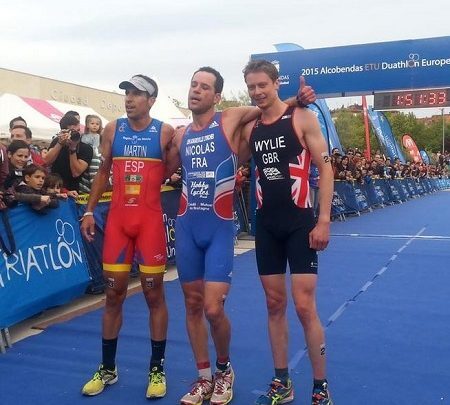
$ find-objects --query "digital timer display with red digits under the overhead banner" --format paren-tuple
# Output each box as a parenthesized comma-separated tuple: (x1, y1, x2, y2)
(374, 89, 450, 110)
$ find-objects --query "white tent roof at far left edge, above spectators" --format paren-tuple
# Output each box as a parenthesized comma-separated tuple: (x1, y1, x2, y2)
(0, 93, 59, 139)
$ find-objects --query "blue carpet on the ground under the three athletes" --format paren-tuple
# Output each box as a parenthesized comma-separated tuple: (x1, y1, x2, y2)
(0, 192, 450, 405)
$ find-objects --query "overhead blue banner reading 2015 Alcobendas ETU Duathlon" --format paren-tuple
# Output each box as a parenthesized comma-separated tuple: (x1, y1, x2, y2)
(251, 36, 450, 98)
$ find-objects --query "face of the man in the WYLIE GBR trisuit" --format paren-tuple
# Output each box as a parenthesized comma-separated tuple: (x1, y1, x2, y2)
(245, 72, 280, 109)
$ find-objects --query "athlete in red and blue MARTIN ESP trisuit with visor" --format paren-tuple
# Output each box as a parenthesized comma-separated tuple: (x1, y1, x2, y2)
(81, 75, 173, 398)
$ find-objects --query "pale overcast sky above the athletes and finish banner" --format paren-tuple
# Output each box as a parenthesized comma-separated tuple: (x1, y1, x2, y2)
(0, 0, 450, 116)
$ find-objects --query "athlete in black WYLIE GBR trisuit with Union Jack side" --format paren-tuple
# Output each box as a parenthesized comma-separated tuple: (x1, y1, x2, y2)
(241, 61, 333, 405)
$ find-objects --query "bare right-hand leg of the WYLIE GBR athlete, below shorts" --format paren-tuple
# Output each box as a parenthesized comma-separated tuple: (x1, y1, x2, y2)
(292, 274, 326, 380)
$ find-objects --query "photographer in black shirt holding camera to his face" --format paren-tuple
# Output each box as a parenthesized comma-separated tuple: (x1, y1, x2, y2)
(44, 114, 93, 191)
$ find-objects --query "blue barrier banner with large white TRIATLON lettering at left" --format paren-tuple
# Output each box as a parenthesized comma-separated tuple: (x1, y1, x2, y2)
(0, 201, 89, 328)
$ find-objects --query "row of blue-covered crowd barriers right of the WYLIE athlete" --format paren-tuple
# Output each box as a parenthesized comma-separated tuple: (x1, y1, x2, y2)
(331, 178, 450, 219)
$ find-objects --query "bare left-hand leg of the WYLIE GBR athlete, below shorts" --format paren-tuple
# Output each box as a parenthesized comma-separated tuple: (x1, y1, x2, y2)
(260, 274, 288, 369)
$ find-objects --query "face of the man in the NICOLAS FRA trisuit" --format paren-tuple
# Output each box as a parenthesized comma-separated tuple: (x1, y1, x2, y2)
(188, 72, 220, 114)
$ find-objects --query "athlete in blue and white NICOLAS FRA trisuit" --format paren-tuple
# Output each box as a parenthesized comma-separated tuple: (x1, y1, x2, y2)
(166, 67, 315, 405)
